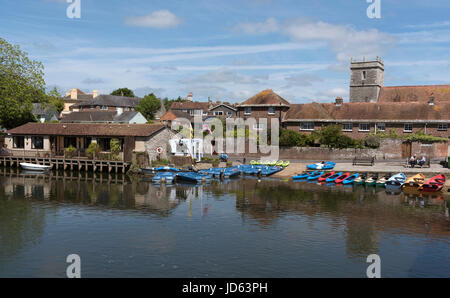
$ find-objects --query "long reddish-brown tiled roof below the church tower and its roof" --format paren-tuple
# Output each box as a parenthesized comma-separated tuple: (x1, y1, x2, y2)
(284, 101, 450, 122)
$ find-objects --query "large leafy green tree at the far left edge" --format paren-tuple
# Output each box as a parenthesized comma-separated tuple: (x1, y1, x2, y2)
(0, 38, 46, 128)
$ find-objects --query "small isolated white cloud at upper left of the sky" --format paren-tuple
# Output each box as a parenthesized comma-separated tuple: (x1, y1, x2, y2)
(125, 10, 182, 29)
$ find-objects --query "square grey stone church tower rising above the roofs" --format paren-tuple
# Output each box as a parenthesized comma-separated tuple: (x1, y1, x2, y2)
(350, 57, 384, 102)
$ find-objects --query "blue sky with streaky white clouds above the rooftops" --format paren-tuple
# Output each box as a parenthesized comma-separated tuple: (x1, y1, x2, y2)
(0, 0, 450, 103)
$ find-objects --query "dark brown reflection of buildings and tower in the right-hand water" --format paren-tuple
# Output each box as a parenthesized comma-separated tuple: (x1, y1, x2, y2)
(227, 179, 450, 257)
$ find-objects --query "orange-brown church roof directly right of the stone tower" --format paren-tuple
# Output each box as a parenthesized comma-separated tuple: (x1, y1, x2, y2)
(378, 85, 450, 102)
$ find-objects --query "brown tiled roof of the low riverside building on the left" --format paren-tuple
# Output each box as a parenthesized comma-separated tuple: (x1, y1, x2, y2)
(6, 122, 165, 137)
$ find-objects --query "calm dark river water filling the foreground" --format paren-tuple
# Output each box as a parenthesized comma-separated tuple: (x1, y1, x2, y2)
(0, 170, 450, 278)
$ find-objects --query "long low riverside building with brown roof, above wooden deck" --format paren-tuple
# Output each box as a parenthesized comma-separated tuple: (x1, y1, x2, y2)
(5, 123, 176, 162)
